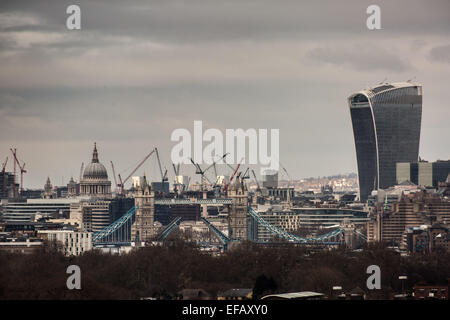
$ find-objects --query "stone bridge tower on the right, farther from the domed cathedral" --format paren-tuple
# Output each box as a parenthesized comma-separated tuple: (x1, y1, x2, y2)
(228, 177, 248, 240)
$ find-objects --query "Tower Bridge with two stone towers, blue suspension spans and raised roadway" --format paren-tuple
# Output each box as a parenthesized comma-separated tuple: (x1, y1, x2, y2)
(93, 178, 364, 249)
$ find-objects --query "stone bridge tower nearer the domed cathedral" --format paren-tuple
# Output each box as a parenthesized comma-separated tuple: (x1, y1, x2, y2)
(131, 176, 156, 245)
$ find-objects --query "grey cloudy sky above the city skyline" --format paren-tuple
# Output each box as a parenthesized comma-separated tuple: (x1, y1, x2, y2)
(0, 0, 450, 187)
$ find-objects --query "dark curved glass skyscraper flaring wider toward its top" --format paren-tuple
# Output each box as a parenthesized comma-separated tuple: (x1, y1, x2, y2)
(348, 82, 422, 201)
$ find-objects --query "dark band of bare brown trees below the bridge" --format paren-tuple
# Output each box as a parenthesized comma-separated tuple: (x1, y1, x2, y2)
(0, 238, 450, 299)
